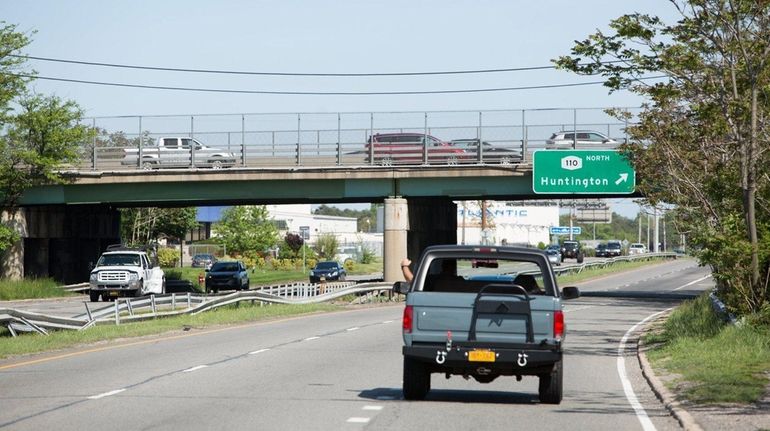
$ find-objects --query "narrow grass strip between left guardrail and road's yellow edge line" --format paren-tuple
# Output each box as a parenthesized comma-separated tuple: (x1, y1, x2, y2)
(0, 303, 339, 358)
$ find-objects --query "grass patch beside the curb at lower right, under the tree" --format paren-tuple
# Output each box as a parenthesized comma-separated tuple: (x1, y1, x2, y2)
(644, 295, 770, 404)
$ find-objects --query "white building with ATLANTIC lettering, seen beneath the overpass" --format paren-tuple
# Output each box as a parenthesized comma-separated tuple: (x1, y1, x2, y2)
(457, 201, 559, 246)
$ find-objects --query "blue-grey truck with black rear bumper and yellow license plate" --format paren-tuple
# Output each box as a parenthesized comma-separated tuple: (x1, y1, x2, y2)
(393, 245, 580, 404)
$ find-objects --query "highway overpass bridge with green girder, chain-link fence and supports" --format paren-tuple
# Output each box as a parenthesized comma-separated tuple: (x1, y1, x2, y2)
(10, 110, 629, 282)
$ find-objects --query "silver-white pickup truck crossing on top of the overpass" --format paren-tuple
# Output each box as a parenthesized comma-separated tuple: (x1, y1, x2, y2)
(122, 136, 236, 169)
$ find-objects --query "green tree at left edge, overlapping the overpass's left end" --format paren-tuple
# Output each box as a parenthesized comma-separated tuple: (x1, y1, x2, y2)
(0, 22, 89, 251)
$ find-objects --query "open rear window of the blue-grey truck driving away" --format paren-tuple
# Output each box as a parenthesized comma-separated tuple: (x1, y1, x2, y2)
(421, 257, 550, 295)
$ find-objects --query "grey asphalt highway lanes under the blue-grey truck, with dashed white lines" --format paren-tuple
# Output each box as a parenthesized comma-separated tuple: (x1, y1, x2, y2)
(0, 260, 713, 431)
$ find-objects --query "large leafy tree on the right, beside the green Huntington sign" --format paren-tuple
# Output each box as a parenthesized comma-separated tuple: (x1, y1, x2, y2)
(556, 0, 770, 313)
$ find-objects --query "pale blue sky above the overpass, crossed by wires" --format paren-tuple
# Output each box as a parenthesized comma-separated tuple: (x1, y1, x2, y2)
(0, 0, 675, 218)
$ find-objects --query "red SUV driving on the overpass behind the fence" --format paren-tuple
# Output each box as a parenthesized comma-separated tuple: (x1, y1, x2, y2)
(366, 133, 469, 166)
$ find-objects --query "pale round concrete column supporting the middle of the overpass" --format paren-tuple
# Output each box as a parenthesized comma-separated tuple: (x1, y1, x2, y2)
(382, 197, 409, 283)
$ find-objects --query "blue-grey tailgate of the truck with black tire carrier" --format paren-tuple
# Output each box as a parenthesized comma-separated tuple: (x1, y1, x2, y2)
(404, 292, 560, 345)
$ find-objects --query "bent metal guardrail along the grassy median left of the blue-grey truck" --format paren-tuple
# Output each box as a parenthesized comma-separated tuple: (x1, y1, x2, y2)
(0, 282, 392, 337)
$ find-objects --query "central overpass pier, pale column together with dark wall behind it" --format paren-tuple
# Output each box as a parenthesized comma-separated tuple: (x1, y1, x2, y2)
(383, 197, 457, 282)
